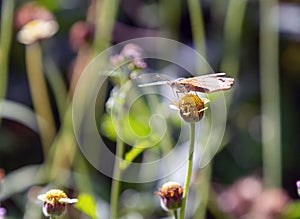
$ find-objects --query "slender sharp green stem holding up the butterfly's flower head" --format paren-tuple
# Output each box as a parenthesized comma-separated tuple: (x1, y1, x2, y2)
(180, 123, 195, 219)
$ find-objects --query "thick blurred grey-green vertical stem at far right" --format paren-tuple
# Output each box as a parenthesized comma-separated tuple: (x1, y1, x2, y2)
(260, 0, 281, 187)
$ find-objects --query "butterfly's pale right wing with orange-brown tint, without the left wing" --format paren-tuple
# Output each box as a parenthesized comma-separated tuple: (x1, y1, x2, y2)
(179, 73, 234, 93)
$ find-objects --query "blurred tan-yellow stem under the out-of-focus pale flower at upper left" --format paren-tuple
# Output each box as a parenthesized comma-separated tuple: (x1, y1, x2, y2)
(26, 43, 56, 154)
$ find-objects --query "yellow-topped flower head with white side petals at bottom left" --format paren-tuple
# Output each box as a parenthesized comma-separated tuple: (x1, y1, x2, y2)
(37, 189, 78, 217)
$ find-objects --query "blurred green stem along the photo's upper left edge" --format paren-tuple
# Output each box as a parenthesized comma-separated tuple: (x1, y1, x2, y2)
(0, 0, 15, 120)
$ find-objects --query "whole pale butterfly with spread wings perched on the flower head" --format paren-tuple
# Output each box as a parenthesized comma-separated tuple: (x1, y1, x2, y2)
(138, 73, 234, 93)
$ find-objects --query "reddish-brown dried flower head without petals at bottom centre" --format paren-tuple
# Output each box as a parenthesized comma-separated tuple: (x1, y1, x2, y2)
(155, 182, 184, 211)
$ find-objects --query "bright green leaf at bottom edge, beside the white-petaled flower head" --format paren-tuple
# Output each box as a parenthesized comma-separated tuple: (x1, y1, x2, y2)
(75, 193, 97, 219)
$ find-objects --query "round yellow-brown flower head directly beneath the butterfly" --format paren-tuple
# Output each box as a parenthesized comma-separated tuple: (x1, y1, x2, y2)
(178, 94, 207, 122)
